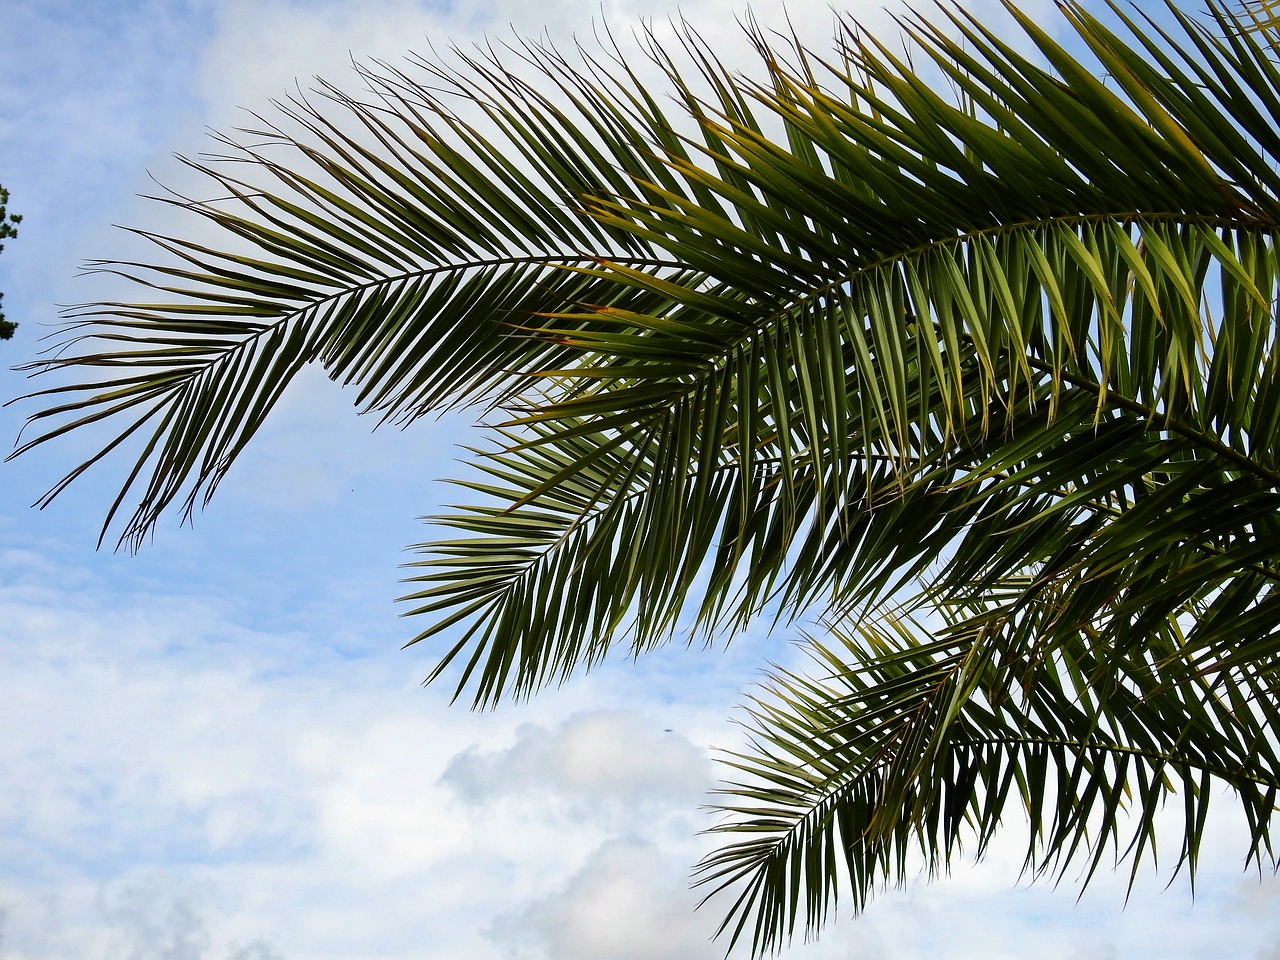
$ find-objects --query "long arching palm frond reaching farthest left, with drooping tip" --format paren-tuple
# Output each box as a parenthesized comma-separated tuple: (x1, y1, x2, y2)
(14, 32, 747, 547)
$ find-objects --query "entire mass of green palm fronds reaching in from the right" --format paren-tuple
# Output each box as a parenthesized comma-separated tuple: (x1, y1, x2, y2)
(12, 5, 1280, 954)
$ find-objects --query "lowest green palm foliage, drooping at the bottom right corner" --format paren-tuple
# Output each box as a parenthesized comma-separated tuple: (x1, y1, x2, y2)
(700, 599, 1280, 954)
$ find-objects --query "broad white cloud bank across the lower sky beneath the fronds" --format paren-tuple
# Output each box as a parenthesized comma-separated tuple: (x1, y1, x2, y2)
(0, 512, 1280, 960)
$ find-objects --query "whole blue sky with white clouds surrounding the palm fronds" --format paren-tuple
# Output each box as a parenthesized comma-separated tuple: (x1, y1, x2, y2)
(0, 0, 1280, 960)
